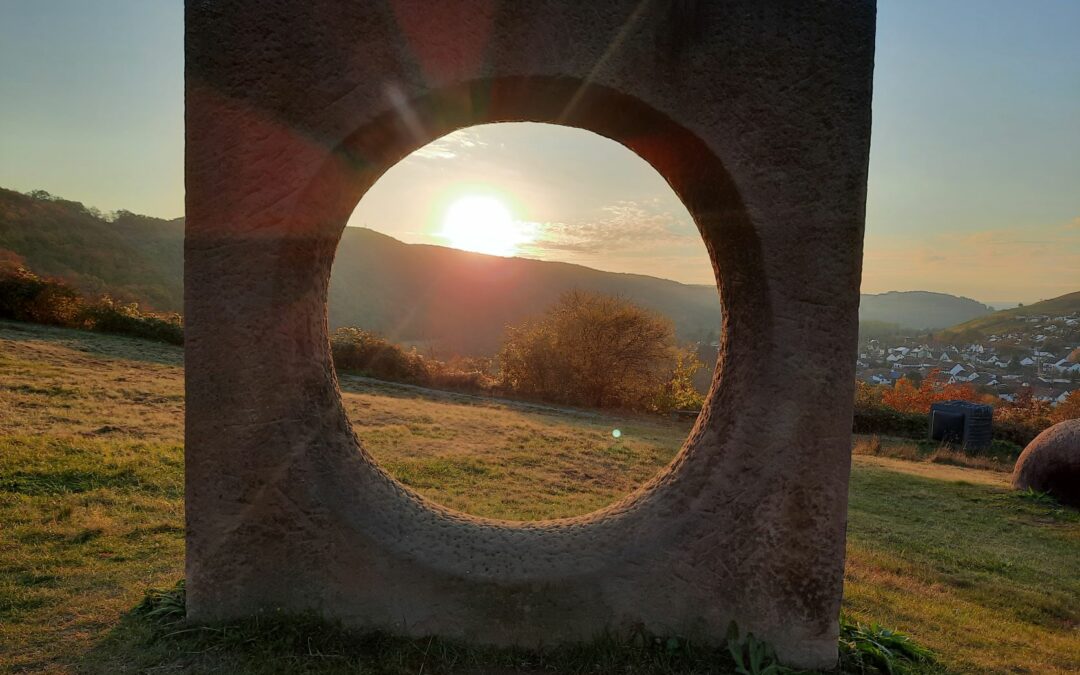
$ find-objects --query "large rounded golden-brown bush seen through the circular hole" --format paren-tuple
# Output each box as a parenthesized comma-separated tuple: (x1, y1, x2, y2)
(499, 291, 682, 409)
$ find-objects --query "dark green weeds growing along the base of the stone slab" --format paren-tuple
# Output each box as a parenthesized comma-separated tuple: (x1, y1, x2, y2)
(118, 581, 945, 675)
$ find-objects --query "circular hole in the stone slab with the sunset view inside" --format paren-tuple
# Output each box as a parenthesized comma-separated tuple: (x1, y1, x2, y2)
(329, 123, 720, 521)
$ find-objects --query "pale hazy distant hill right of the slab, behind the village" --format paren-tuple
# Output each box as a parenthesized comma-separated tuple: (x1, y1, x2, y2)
(859, 291, 994, 330)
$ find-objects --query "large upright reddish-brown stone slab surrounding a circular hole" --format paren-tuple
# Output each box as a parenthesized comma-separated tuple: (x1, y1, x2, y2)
(185, 0, 875, 666)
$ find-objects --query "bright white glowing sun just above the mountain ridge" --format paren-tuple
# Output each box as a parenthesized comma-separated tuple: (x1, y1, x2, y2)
(436, 194, 534, 256)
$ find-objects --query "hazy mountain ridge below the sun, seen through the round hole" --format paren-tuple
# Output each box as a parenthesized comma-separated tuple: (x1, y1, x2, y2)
(329, 228, 720, 354)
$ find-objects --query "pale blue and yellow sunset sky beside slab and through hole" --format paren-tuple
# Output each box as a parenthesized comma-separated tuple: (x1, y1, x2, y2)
(0, 0, 1080, 307)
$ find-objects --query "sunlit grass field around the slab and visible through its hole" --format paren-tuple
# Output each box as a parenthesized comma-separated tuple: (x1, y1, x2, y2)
(0, 322, 1080, 674)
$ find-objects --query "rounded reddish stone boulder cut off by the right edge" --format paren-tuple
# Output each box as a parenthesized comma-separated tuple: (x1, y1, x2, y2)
(1012, 419, 1080, 507)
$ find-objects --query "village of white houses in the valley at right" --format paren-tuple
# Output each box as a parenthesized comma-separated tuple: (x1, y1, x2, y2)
(855, 312, 1080, 405)
